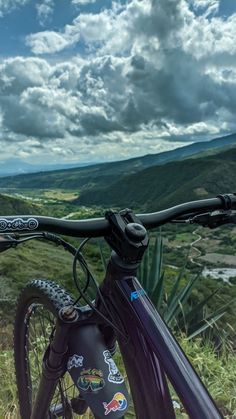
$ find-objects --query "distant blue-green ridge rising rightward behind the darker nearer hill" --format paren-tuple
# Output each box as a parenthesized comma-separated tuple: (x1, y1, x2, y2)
(0, 134, 236, 192)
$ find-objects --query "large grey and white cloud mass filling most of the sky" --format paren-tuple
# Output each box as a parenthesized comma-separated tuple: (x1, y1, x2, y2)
(0, 0, 236, 162)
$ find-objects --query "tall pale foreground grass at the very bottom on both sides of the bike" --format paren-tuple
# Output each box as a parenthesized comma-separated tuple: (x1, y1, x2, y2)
(0, 336, 236, 419)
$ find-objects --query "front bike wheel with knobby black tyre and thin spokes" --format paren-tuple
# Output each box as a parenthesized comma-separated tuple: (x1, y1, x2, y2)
(14, 280, 87, 419)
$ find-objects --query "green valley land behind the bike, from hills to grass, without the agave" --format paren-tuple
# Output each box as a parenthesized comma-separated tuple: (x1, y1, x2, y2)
(0, 137, 236, 419)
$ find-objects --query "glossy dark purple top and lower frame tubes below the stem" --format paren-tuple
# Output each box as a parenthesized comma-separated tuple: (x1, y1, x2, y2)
(102, 257, 223, 419)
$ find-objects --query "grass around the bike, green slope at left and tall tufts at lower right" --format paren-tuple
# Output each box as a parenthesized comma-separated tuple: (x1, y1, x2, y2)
(0, 241, 236, 419)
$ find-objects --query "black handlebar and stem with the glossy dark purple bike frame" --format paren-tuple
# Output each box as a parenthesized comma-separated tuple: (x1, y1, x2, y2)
(4, 195, 236, 419)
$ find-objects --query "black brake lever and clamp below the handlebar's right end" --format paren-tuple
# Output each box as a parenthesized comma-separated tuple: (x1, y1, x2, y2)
(189, 211, 236, 229)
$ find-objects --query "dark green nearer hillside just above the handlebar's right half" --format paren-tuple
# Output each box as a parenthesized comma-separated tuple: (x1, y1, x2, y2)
(77, 148, 236, 211)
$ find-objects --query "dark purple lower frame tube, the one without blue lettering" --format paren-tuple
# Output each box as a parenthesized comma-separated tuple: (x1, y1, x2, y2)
(101, 256, 175, 419)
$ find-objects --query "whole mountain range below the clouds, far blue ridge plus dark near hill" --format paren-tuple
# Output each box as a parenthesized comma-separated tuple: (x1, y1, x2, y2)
(0, 135, 236, 211)
